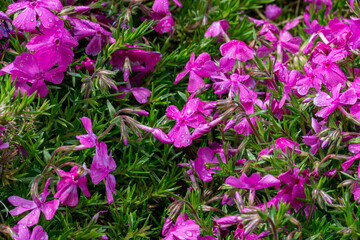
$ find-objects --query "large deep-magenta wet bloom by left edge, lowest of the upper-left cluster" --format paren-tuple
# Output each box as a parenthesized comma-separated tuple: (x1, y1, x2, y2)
(5, 51, 65, 97)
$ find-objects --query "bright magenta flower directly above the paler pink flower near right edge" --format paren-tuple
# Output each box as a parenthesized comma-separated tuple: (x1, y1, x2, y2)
(313, 49, 347, 89)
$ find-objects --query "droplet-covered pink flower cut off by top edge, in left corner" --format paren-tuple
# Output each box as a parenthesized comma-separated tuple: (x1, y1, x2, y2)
(6, 0, 63, 31)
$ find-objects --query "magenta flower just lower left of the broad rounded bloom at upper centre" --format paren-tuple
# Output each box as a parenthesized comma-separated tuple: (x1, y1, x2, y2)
(174, 53, 211, 93)
